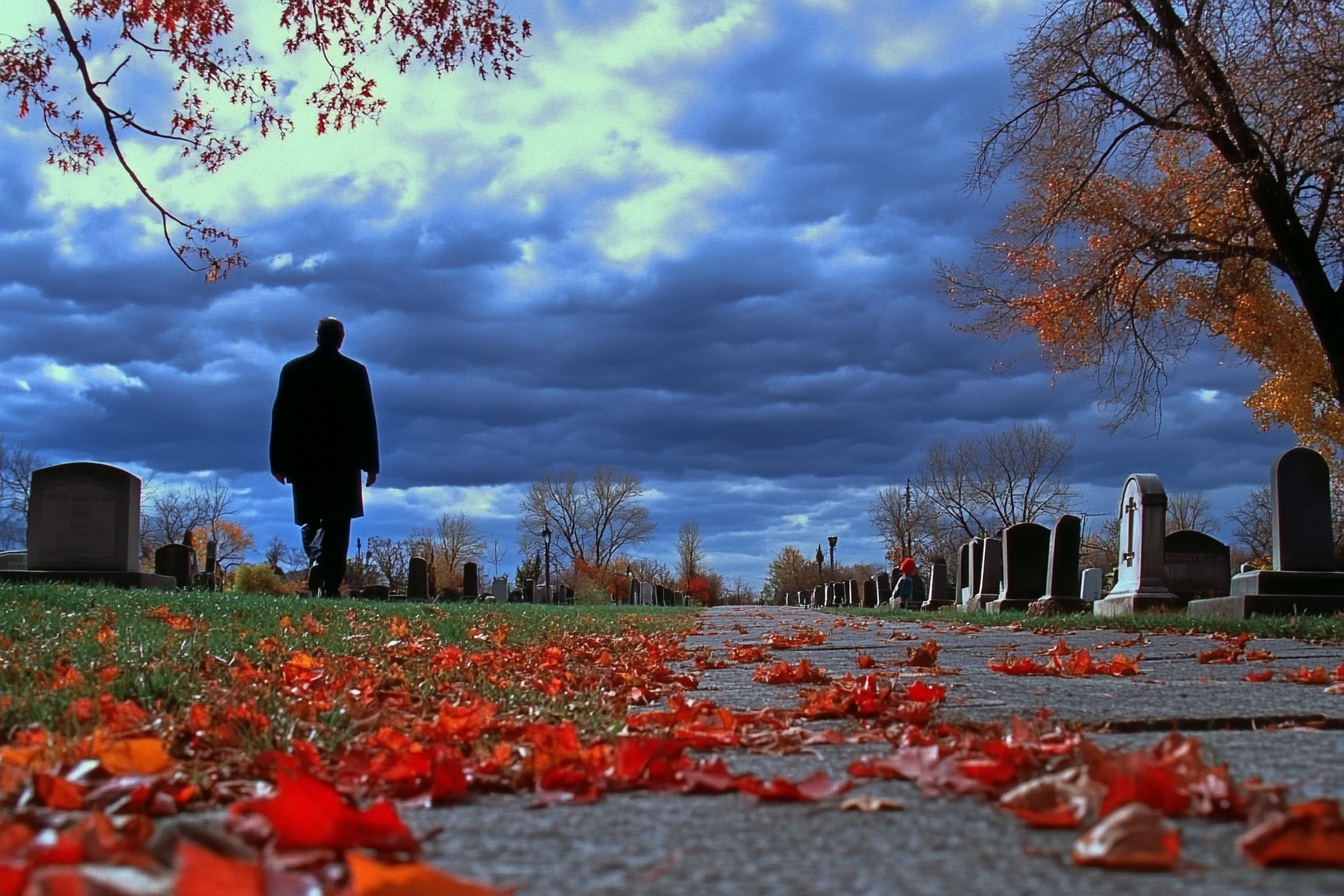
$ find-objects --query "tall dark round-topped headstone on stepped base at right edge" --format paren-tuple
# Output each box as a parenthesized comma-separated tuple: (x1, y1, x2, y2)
(1188, 447, 1344, 619)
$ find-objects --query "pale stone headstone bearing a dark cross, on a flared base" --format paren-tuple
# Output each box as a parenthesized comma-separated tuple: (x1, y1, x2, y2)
(1093, 473, 1184, 617)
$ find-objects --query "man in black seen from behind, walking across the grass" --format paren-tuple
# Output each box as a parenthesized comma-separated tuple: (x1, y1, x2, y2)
(270, 317, 378, 598)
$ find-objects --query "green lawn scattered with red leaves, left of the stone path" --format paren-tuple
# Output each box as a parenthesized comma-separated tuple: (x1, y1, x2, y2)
(0, 584, 695, 740)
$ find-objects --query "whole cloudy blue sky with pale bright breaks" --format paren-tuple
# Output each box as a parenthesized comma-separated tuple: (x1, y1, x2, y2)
(0, 0, 1293, 583)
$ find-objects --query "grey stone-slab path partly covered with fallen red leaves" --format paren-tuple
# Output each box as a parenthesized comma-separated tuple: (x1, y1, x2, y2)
(407, 607, 1344, 896)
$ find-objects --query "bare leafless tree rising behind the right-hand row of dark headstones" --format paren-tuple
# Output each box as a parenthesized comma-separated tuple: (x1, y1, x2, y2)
(915, 423, 1078, 542)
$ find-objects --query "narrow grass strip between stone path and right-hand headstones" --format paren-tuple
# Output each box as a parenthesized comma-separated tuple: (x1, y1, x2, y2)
(816, 607, 1344, 643)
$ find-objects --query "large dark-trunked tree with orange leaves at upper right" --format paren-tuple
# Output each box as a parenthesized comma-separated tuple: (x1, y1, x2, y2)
(941, 0, 1344, 451)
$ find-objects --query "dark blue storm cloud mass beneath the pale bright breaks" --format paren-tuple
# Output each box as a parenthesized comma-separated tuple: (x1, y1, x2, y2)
(0, 0, 1292, 578)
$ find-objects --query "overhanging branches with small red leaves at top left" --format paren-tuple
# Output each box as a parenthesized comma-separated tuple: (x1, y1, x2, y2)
(0, 0, 531, 279)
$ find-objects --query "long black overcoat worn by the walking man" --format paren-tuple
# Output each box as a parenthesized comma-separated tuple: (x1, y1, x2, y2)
(270, 347, 378, 525)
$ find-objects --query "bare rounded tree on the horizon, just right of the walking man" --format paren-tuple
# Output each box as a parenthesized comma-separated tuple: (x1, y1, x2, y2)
(517, 466, 655, 568)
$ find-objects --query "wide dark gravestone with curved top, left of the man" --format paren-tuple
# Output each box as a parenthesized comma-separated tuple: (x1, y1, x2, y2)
(0, 462, 177, 591)
